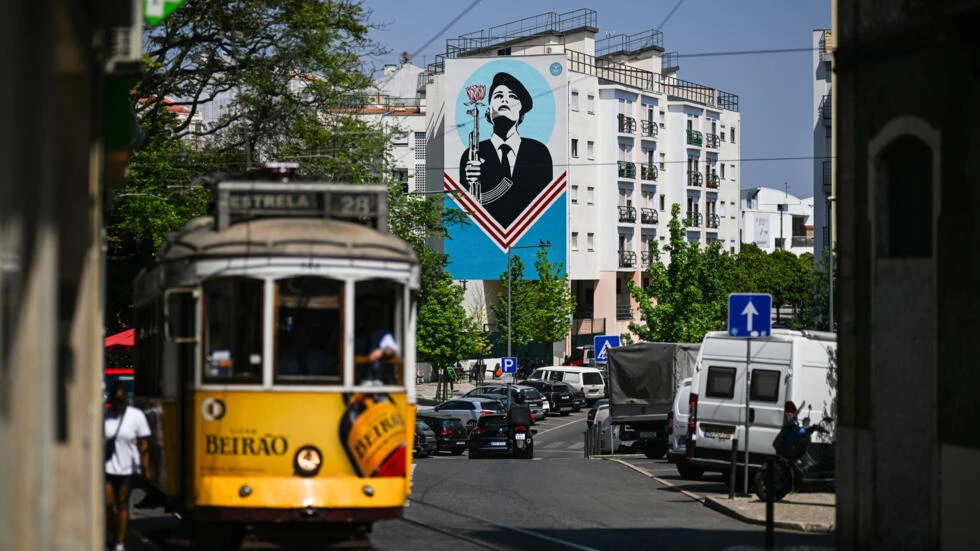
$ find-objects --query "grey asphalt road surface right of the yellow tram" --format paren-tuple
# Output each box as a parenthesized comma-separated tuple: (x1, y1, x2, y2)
(371, 410, 834, 550)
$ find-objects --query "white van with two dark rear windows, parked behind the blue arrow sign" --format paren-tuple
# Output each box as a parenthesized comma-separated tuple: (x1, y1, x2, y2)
(686, 329, 837, 473)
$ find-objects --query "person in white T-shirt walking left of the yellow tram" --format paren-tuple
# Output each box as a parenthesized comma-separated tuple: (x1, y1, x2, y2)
(103, 382, 150, 551)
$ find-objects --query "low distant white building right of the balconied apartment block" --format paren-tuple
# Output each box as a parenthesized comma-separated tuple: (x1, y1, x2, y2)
(741, 187, 814, 256)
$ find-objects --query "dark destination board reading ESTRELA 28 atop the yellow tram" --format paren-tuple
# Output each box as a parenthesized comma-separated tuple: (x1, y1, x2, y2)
(217, 182, 387, 230)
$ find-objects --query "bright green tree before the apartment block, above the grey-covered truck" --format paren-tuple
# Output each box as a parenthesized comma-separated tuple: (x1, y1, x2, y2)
(628, 203, 731, 342)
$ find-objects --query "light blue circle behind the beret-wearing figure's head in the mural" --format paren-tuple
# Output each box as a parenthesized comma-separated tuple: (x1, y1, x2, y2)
(456, 59, 561, 147)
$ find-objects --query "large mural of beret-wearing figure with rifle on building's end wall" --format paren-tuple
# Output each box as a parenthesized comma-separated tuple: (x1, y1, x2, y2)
(443, 55, 568, 279)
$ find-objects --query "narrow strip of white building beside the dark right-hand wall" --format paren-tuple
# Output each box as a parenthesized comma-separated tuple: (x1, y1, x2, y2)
(812, 29, 834, 260)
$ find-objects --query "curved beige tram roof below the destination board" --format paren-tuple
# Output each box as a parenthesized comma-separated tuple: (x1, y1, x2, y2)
(157, 216, 418, 264)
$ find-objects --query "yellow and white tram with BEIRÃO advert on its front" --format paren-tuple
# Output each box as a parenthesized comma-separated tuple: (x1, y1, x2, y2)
(135, 165, 419, 538)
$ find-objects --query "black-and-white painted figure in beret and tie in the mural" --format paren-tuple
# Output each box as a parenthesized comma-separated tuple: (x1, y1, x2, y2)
(459, 72, 554, 228)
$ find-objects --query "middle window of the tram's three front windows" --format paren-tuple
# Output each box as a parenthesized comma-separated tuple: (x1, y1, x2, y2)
(275, 277, 344, 384)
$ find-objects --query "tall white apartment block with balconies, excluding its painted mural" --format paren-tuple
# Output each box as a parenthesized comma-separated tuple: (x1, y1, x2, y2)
(419, 9, 741, 336)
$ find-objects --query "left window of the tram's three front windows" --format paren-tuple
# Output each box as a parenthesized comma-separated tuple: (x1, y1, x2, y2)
(204, 278, 262, 383)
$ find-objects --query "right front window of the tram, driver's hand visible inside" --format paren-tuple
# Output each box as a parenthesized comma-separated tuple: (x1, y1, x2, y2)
(354, 279, 405, 385)
